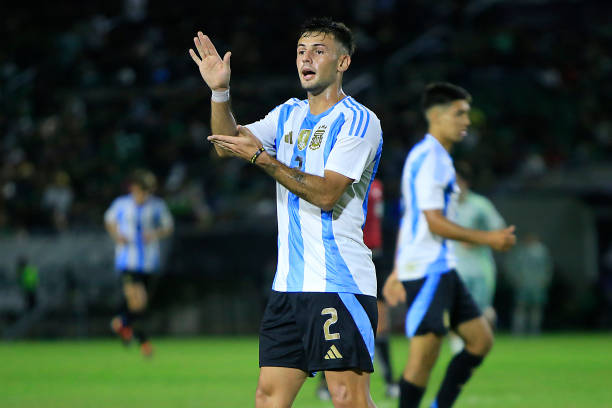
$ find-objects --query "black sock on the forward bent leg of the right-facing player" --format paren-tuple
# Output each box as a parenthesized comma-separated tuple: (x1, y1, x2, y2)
(431, 349, 484, 408)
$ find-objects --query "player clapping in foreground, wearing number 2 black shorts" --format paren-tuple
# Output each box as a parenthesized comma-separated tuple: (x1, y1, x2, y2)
(190, 19, 382, 408)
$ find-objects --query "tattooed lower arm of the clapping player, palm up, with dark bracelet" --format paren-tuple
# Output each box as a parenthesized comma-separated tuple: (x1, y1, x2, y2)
(208, 126, 354, 211)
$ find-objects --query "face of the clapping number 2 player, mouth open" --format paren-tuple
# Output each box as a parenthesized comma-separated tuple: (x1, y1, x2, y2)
(296, 33, 348, 95)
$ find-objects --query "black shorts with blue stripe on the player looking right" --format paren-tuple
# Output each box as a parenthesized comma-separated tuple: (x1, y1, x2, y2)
(402, 269, 482, 337)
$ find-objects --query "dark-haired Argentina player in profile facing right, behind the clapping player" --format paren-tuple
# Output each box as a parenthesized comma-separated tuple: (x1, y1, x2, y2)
(383, 83, 516, 408)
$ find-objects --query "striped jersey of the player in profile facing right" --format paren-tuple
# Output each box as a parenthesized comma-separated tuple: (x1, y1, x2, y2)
(396, 134, 459, 281)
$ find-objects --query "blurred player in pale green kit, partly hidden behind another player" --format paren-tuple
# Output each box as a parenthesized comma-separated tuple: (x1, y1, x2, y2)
(450, 162, 506, 353)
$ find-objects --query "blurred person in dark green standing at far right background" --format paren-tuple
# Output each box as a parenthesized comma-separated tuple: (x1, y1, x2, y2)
(506, 232, 553, 335)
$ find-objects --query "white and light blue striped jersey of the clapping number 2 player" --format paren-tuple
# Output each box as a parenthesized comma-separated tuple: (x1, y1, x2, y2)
(247, 97, 382, 296)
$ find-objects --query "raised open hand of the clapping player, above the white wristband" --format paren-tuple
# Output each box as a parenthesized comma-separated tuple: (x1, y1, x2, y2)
(189, 31, 232, 91)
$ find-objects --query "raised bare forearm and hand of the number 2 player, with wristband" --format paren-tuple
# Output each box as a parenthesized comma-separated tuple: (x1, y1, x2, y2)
(189, 31, 238, 157)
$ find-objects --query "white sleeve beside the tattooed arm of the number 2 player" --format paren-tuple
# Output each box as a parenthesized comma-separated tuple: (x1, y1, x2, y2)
(325, 112, 382, 183)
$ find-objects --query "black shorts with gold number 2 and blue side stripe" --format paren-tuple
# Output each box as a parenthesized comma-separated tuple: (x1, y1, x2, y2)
(259, 291, 378, 375)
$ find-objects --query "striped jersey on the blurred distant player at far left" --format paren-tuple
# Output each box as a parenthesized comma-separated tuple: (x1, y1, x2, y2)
(104, 194, 174, 273)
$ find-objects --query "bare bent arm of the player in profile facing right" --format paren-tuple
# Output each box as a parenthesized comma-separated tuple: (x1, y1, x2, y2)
(423, 209, 516, 251)
